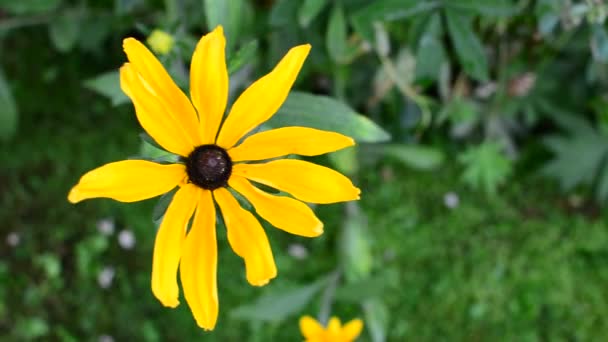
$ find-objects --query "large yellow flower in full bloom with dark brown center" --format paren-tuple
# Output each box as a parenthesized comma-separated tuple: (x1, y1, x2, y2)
(68, 26, 360, 329)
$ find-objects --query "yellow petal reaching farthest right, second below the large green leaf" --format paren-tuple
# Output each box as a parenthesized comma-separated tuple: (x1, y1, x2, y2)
(232, 159, 361, 203)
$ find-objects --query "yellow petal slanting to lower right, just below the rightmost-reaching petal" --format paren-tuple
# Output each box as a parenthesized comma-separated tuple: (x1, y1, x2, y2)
(228, 176, 323, 237)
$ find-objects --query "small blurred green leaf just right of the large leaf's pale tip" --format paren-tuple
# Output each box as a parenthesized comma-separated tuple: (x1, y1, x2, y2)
(384, 144, 444, 170)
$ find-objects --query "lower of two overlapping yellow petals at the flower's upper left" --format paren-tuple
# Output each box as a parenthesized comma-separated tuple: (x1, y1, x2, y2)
(120, 63, 200, 157)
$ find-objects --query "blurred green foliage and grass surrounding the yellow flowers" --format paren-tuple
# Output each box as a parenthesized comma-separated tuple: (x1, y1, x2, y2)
(0, 0, 608, 342)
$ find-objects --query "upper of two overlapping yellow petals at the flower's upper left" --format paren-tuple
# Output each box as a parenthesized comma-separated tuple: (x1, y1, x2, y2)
(123, 38, 201, 150)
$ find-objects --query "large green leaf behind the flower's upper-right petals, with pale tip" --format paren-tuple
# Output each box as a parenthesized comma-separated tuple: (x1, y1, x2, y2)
(267, 91, 390, 143)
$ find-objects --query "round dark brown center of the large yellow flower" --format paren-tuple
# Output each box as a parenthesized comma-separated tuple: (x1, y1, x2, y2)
(186, 145, 232, 190)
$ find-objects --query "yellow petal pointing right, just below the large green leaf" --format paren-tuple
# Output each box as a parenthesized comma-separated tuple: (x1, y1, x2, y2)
(228, 127, 355, 162)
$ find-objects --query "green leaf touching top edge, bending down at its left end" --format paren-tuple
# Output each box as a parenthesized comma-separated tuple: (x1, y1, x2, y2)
(350, 0, 441, 42)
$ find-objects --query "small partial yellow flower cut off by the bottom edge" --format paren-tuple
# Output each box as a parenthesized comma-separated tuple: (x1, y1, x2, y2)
(300, 316, 363, 342)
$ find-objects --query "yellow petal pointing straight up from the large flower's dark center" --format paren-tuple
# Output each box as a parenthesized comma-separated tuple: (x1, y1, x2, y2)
(190, 26, 228, 144)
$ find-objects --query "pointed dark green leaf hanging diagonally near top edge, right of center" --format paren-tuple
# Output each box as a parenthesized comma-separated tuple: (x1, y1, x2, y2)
(445, 10, 489, 81)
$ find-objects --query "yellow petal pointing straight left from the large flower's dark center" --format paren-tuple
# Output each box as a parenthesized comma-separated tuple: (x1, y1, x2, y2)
(68, 160, 186, 203)
